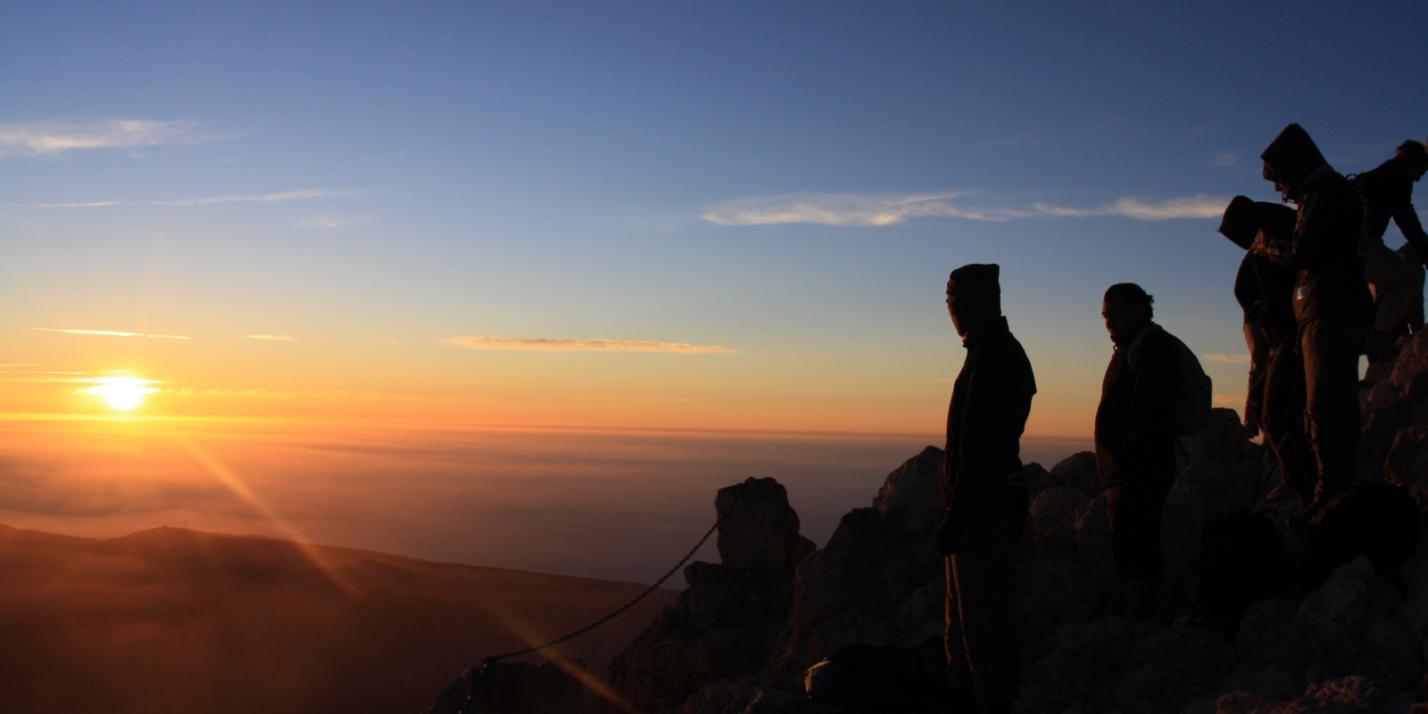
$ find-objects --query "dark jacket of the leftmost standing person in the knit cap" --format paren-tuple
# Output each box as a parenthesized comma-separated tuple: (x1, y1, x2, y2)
(942, 317, 1037, 521)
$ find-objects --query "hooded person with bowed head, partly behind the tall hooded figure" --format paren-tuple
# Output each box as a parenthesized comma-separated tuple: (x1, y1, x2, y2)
(1220, 196, 1317, 504)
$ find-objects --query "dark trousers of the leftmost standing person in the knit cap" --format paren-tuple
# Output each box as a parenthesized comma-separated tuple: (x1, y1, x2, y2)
(947, 516, 1025, 713)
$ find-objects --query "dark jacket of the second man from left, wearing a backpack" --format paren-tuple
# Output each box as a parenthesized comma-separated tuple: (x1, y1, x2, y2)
(1095, 323, 1181, 487)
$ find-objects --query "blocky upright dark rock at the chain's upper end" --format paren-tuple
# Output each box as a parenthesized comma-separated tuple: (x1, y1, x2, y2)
(714, 478, 814, 574)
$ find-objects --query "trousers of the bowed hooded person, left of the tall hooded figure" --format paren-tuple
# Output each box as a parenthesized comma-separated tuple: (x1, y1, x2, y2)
(1261, 340, 1318, 504)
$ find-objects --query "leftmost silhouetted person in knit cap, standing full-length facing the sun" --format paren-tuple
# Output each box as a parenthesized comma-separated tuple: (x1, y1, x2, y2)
(935, 264, 1037, 713)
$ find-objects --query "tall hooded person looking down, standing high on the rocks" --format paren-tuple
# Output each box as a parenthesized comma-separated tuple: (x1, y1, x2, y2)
(1261, 124, 1372, 517)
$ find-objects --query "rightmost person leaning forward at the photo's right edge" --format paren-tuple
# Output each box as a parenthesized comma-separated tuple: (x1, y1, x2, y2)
(1354, 141, 1428, 361)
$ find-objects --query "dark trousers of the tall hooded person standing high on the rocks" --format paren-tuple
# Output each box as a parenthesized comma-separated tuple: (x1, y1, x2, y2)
(1299, 320, 1364, 504)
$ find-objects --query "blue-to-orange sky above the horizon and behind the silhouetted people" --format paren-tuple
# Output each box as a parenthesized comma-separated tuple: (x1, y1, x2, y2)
(0, 1, 1428, 438)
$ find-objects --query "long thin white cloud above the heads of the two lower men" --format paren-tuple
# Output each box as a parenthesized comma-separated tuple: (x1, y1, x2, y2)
(700, 193, 1230, 227)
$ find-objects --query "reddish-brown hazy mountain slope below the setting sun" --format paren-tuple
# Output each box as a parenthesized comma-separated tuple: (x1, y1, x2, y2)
(0, 526, 675, 714)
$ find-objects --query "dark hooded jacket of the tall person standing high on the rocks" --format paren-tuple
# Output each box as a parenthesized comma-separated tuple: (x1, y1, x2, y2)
(1261, 124, 1374, 324)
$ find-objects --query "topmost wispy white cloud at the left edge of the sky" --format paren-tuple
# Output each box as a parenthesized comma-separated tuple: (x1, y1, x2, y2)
(0, 119, 238, 159)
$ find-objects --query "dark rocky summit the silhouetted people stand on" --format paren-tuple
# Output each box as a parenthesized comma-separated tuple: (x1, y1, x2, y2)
(430, 333, 1428, 714)
